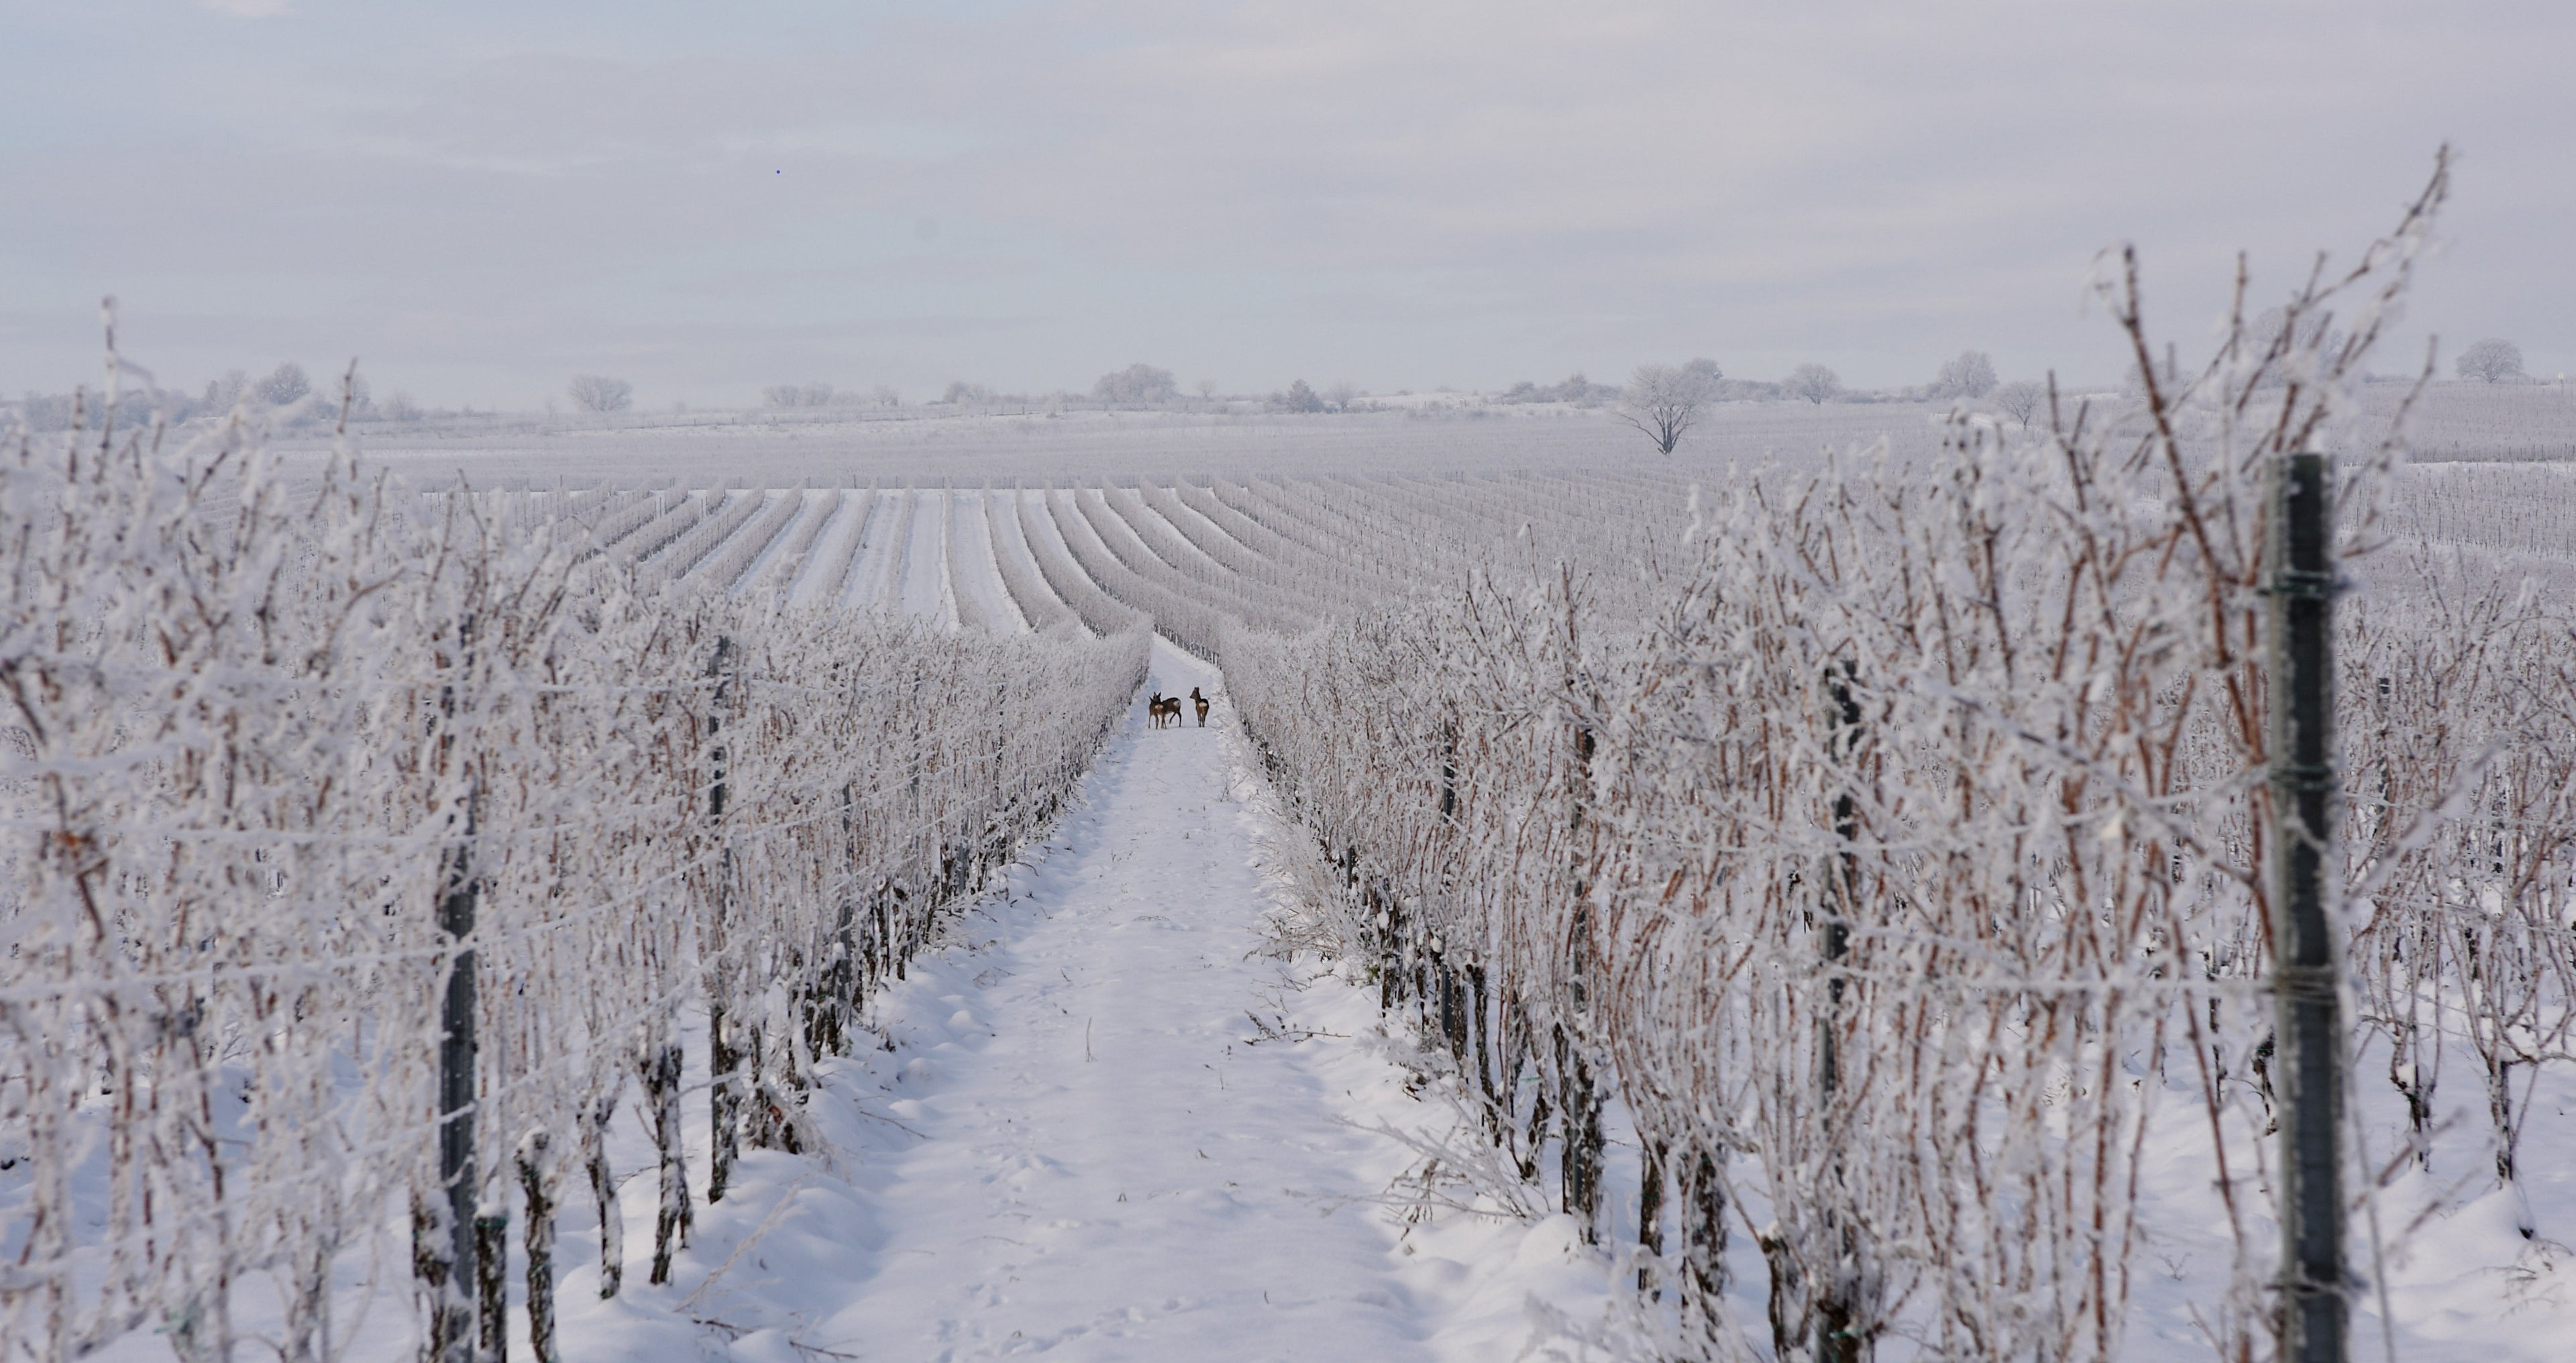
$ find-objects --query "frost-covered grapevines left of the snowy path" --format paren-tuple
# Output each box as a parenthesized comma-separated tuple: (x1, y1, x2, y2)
(0, 389, 1144, 1358)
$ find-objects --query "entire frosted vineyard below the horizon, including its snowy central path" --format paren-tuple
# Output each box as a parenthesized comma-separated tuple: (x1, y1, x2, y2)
(0, 250, 2576, 1360)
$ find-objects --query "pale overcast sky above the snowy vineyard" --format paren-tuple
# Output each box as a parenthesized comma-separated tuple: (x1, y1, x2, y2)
(0, 0, 2576, 407)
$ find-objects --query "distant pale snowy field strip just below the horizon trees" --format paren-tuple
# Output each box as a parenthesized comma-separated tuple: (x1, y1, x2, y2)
(251, 384, 2576, 487)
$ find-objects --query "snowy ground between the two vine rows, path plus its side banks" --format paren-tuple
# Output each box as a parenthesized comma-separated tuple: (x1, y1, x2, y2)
(541, 641, 1613, 1363)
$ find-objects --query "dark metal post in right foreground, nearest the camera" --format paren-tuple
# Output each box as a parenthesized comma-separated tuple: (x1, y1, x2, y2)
(2267, 453, 2349, 1363)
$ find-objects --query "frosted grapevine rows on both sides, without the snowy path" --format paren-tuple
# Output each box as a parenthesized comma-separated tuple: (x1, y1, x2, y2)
(0, 182, 2576, 1360)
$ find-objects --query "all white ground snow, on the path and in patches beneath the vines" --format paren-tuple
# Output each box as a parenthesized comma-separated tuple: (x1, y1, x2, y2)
(85, 623, 2576, 1363)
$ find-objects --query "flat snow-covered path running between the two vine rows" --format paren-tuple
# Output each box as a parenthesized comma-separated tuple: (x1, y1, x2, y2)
(812, 649, 1422, 1360)
